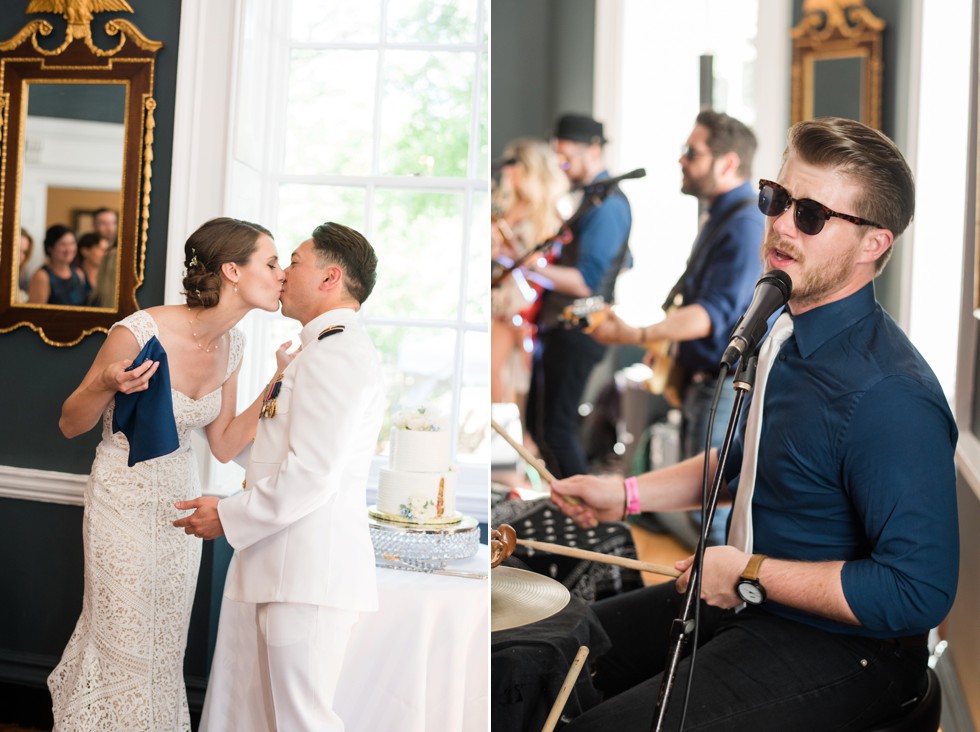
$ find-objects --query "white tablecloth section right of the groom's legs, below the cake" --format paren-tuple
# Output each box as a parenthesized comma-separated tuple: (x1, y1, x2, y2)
(334, 545, 490, 732)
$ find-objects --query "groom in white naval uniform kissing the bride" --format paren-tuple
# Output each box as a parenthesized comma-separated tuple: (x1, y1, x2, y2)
(174, 223, 385, 732)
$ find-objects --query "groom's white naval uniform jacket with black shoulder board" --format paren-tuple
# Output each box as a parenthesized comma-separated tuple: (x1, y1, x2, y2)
(218, 309, 385, 610)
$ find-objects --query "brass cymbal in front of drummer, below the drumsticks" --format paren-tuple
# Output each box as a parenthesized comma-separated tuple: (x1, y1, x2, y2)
(490, 567, 570, 631)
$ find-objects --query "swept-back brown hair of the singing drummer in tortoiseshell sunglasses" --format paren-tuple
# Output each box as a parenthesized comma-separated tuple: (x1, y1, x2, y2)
(783, 117, 915, 274)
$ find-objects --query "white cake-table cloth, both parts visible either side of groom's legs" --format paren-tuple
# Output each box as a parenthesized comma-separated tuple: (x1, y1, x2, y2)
(202, 545, 490, 732)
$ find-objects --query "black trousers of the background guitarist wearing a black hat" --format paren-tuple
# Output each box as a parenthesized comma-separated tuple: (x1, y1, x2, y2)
(527, 328, 606, 478)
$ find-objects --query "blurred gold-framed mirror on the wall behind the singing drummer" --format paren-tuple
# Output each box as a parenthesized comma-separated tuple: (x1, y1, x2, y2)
(790, 0, 885, 128)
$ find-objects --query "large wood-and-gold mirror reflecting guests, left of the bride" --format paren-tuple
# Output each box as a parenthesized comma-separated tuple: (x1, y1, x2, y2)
(0, 0, 162, 346)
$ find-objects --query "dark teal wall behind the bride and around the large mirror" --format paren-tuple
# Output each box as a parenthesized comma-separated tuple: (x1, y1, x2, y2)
(0, 0, 195, 721)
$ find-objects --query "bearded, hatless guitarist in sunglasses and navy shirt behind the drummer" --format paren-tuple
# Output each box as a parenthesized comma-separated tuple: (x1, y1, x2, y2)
(592, 111, 765, 547)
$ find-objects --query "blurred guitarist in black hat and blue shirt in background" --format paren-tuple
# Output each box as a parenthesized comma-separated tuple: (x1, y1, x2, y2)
(527, 114, 632, 476)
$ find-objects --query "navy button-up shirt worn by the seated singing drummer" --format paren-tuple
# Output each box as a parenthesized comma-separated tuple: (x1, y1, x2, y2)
(726, 284, 959, 638)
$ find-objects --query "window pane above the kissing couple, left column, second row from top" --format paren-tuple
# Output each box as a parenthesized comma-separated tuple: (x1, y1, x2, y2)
(285, 50, 378, 175)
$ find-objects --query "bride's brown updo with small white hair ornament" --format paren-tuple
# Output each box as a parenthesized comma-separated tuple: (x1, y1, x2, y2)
(183, 217, 272, 308)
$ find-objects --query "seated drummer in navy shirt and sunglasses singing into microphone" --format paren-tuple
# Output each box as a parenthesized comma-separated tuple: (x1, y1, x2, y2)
(552, 118, 959, 732)
